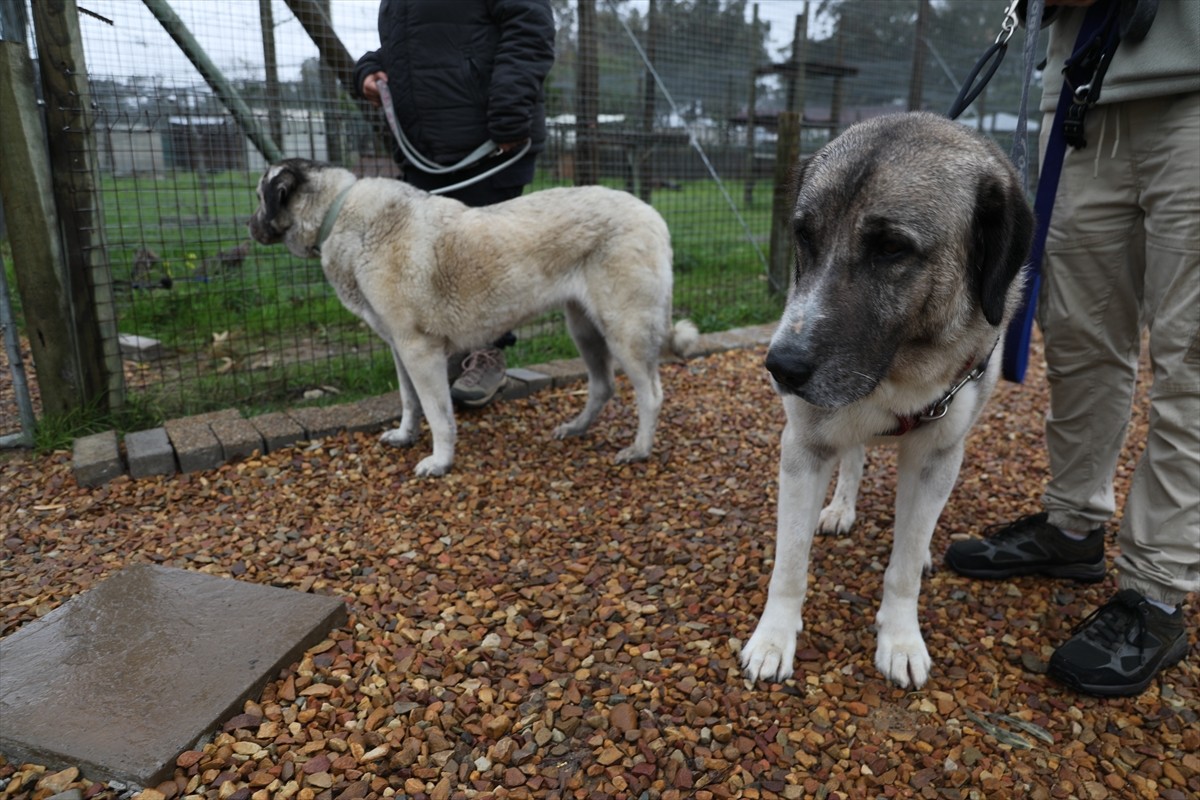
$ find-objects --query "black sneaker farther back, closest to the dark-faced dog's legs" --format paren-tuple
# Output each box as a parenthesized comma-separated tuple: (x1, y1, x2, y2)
(946, 512, 1106, 583)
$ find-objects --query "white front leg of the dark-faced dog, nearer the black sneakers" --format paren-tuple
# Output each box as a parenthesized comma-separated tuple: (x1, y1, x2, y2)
(875, 440, 962, 688)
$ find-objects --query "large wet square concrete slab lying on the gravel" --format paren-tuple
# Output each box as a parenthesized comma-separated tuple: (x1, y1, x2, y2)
(0, 565, 346, 786)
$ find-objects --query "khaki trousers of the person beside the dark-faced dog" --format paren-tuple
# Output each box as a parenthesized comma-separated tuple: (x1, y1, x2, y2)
(1038, 94, 1200, 603)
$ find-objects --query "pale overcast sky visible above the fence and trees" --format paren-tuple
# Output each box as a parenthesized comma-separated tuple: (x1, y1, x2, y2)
(70, 0, 804, 83)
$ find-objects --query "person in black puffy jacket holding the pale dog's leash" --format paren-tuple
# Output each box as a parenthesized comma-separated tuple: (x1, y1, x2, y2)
(354, 0, 554, 408)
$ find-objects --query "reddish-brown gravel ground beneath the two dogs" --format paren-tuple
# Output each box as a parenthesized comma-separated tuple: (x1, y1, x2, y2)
(0, 338, 1200, 800)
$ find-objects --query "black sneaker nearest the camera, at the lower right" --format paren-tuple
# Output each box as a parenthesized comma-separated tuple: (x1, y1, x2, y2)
(1049, 589, 1188, 696)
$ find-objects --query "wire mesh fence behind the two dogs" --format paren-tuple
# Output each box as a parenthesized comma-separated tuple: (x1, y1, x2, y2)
(2, 0, 1036, 429)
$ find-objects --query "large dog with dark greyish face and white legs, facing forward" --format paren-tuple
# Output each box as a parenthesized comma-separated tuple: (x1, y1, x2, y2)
(742, 113, 1033, 687)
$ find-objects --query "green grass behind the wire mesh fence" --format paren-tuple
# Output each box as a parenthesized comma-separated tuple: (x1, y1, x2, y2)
(7, 166, 782, 434)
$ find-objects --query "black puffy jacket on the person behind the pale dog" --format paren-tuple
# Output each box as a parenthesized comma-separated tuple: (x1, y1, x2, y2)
(354, 0, 554, 170)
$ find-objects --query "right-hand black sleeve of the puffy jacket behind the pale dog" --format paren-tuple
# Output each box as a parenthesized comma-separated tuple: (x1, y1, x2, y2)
(487, 0, 554, 143)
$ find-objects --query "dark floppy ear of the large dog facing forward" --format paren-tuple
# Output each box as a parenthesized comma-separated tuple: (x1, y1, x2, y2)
(968, 175, 1033, 325)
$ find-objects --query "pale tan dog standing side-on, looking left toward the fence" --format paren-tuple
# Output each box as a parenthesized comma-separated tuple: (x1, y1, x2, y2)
(250, 158, 697, 476)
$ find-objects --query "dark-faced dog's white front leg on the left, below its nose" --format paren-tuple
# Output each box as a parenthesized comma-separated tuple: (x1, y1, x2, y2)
(742, 412, 834, 681)
